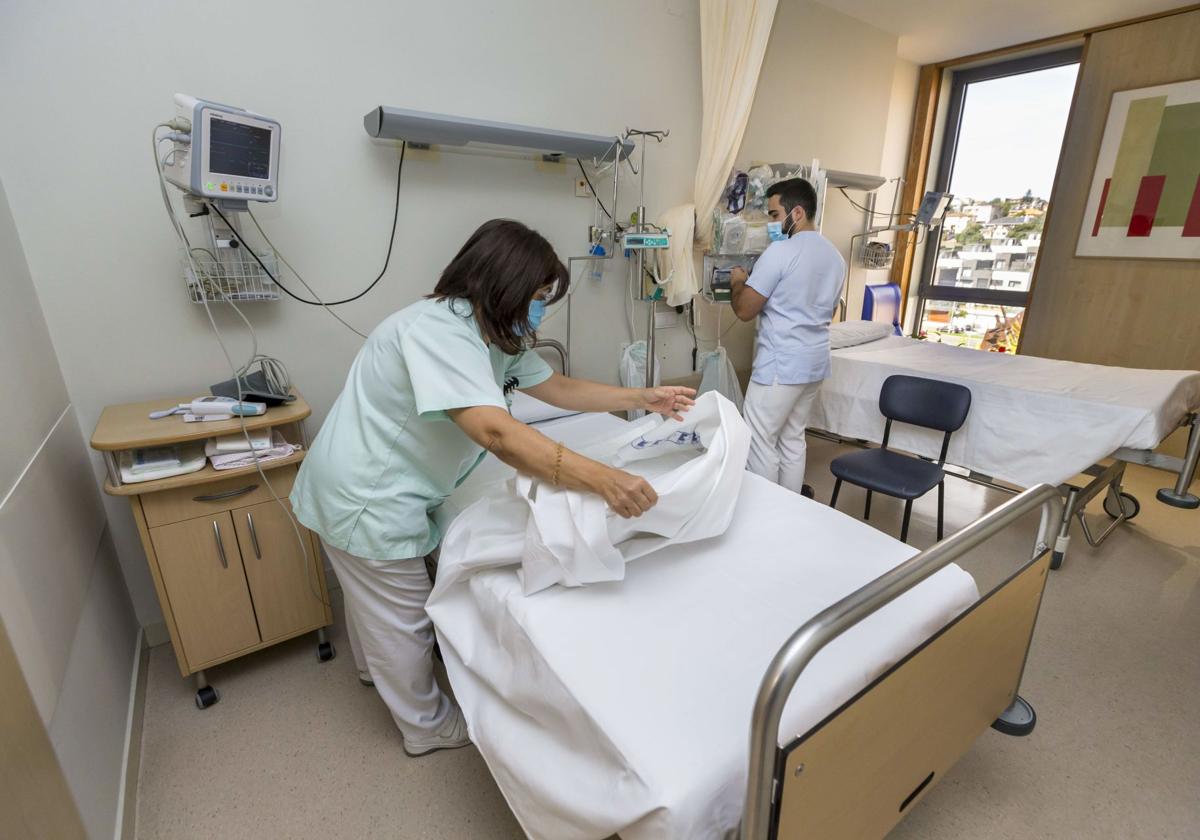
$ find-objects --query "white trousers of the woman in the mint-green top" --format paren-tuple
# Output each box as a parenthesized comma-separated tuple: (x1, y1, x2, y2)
(322, 540, 452, 739)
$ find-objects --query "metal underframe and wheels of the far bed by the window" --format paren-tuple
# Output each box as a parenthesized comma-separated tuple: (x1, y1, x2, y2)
(809, 414, 1200, 569)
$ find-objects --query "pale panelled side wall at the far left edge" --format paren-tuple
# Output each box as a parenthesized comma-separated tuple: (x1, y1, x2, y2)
(0, 174, 137, 836)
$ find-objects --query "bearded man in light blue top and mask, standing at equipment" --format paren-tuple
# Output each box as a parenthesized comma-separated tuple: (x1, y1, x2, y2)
(730, 178, 846, 497)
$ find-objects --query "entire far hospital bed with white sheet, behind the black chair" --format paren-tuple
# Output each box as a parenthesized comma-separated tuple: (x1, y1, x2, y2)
(810, 331, 1200, 569)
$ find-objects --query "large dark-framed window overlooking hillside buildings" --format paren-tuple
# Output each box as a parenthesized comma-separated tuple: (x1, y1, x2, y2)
(916, 49, 1080, 352)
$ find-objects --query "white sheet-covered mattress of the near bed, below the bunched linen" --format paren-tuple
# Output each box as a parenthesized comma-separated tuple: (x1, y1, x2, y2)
(428, 414, 978, 840)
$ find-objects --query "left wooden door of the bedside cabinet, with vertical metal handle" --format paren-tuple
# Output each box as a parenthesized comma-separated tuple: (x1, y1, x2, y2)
(150, 511, 260, 670)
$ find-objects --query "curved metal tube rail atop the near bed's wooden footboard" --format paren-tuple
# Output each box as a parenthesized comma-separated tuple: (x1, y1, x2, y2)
(742, 484, 1061, 840)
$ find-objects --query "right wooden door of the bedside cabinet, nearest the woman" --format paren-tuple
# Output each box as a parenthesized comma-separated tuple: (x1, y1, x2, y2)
(233, 499, 326, 642)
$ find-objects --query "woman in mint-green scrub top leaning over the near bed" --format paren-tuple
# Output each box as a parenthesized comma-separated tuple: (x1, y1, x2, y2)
(290, 220, 695, 756)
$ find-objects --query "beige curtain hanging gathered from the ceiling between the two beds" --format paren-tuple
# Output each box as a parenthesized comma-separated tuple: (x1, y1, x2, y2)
(660, 0, 779, 306)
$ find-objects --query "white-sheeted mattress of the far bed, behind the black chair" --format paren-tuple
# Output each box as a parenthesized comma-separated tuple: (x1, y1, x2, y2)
(810, 336, 1200, 487)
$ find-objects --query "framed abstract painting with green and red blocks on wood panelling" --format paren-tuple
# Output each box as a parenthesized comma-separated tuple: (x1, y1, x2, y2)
(1075, 79, 1200, 259)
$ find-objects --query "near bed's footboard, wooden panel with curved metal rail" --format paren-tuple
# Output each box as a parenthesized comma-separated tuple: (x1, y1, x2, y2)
(740, 484, 1060, 840)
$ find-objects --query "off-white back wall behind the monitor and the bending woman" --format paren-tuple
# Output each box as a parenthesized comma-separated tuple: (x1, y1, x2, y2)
(0, 0, 700, 624)
